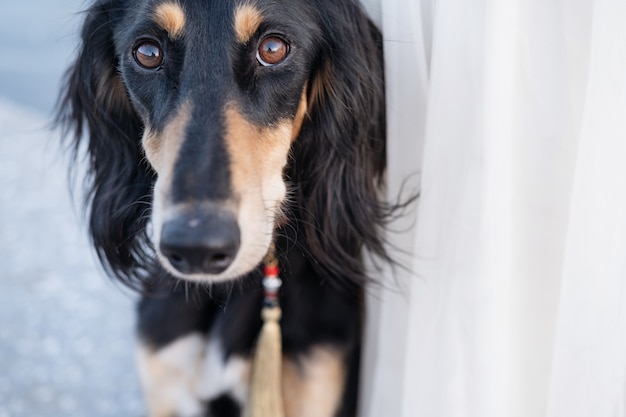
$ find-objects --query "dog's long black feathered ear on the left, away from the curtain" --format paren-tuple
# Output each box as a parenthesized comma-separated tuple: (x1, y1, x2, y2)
(56, 0, 154, 285)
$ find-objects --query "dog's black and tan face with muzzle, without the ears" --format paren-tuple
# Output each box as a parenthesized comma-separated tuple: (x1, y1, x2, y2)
(115, 0, 321, 281)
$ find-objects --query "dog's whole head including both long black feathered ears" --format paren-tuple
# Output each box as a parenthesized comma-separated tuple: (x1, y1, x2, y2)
(61, 0, 384, 281)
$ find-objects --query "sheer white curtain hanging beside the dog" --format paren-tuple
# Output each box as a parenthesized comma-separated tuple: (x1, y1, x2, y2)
(361, 0, 626, 417)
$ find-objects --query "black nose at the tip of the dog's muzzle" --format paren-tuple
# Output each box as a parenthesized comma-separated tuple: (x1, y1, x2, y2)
(159, 211, 240, 274)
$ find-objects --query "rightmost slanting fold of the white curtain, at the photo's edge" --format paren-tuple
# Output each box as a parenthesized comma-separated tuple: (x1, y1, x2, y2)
(549, 0, 626, 417)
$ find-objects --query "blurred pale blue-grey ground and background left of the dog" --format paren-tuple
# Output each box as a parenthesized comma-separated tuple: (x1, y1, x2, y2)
(0, 0, 144, 417)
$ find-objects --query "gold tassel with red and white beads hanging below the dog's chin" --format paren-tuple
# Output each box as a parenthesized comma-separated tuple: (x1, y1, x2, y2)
(244, 250, 285, 417)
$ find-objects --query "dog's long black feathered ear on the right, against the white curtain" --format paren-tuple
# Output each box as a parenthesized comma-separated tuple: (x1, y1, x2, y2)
(288, 1, 392, 283)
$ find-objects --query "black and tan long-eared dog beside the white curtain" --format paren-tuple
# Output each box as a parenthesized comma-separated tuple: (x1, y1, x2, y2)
(57, 0, 394, 417)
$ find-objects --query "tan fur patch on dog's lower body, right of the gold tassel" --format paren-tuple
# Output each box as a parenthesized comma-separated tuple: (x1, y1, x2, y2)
(283, 347, 346, 417)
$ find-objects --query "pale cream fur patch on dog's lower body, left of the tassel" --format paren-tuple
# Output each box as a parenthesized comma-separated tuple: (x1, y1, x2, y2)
(137, 334, 206, 417)
